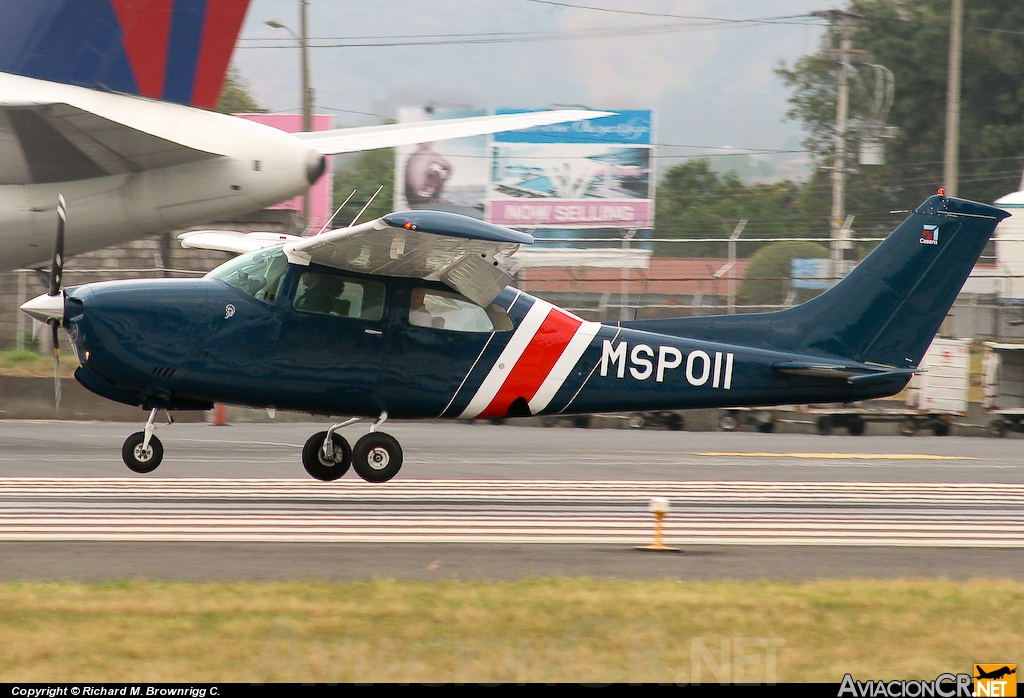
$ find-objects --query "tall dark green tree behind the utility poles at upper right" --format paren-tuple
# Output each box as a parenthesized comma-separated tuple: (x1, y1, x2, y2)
(778, 0, 1024, 216)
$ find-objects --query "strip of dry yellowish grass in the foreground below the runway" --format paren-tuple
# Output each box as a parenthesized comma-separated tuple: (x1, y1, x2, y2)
(0, 578, 1024, 683)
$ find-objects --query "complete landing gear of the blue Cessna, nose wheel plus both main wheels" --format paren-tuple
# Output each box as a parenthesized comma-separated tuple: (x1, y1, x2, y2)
(121, 409, 401, 482)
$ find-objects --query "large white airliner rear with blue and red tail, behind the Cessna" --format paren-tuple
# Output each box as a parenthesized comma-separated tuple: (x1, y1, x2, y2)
(0, 0, 608, 271)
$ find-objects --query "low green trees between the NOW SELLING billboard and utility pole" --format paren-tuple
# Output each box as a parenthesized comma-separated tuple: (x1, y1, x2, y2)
(654, 159, 826, 257)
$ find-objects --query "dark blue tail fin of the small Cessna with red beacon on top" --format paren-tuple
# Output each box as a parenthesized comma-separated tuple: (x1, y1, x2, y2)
(623, 197, 1010, 368)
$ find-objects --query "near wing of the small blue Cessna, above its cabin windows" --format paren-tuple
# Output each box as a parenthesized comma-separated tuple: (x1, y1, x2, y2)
(285, 211, 534, 306)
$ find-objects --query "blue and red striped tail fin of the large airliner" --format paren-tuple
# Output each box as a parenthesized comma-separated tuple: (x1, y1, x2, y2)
(0, 0, 250, 108)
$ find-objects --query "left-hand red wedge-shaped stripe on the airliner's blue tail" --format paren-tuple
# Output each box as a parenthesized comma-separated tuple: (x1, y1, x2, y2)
(111, 0, 173, 99)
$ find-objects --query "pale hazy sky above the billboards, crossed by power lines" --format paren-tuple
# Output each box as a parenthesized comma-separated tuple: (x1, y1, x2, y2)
(234, 0, 842, 179)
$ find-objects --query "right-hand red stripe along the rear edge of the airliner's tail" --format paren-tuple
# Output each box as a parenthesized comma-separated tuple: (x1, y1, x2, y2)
(191, 0, 249, 110)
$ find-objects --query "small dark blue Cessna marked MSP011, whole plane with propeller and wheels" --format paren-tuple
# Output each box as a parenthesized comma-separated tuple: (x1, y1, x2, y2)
(23, 194, 1008, 482)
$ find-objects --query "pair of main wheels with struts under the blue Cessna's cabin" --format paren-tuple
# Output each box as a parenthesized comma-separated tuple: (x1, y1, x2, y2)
(302, 412, 401, 482)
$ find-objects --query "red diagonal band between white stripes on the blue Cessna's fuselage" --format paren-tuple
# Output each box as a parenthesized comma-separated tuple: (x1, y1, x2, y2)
(477, 308, 583, 419)
